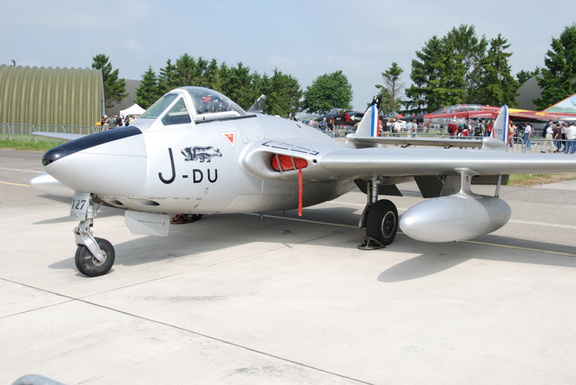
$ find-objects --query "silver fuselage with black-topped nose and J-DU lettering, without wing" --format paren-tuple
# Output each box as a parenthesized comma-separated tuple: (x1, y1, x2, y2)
(44, 90, 353, 214)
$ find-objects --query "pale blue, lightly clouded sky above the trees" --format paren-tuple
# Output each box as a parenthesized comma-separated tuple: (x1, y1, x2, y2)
(0, 0, 576, 109)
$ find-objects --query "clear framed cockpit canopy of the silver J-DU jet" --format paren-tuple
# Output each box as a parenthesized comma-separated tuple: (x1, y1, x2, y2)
(140, 87, 246, 125)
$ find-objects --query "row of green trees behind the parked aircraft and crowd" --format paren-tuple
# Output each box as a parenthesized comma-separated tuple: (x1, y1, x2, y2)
(92, 24, 576, 117)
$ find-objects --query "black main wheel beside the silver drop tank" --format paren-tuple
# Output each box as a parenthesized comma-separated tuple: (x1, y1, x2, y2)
(366, 199, 398, 246)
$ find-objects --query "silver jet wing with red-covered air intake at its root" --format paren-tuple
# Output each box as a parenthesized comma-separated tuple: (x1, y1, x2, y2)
(244, 143, 576, 182)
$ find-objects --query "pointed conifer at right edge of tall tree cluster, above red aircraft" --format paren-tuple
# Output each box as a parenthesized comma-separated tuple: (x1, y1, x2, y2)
(476, 34, 520, 106)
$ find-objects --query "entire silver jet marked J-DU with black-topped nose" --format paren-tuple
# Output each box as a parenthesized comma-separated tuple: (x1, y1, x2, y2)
(31, 87, 576, 276)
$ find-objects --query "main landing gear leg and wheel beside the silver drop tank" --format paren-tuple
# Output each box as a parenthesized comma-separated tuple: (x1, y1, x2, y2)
(358, 178, 398, 250)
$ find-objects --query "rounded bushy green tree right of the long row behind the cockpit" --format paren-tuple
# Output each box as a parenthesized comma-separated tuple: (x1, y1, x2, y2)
(302, 71, 353, 114)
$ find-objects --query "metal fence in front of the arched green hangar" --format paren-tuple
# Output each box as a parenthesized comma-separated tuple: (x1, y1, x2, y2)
(0, 123, 100, 141)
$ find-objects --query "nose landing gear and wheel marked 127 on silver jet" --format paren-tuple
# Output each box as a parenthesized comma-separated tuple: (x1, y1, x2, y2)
(71, 193, 115, 277)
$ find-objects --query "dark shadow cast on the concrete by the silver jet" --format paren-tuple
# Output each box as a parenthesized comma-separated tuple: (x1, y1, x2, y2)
(42, 208, 576, 283)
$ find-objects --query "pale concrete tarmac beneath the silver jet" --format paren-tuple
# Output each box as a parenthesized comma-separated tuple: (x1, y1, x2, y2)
(0, 150, 576, 385)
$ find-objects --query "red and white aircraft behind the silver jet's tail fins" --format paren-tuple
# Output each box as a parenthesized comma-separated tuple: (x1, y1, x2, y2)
(407, 94, 576, 124)
